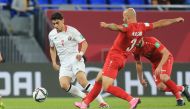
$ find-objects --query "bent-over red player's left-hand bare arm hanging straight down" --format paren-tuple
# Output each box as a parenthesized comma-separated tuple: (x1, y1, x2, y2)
(136, 61, 147, 87)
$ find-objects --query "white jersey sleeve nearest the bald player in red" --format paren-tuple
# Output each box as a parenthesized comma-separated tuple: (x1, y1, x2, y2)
(73, 28, 85, 43)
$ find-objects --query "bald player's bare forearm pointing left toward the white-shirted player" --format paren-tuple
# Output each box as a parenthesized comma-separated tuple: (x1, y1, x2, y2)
(100, 22, 124, 32)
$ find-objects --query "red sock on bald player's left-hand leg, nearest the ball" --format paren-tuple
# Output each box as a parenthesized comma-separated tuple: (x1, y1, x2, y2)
(83, 81, 102, 105)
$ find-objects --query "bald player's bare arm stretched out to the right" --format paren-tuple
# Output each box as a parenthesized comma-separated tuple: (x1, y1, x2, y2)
(153, 17, 184, 28)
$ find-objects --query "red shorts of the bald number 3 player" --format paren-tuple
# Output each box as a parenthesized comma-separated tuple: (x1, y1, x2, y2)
(103, 53, 126, 79)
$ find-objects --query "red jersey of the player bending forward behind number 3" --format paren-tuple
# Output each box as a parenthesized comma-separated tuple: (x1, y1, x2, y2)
(133, 37, 172, 63)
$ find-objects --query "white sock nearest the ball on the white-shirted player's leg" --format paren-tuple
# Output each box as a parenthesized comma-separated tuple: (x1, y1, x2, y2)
(67, 85, 86, 98)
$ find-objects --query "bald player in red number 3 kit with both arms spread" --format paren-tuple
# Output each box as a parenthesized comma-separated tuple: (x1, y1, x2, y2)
(75, 8, 183, 109)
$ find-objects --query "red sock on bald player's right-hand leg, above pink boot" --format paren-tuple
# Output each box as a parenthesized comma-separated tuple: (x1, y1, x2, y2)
(107, 85, 133, 102)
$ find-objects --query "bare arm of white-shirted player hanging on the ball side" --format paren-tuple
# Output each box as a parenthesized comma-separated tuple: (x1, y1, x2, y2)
(50, 47, 60, 71)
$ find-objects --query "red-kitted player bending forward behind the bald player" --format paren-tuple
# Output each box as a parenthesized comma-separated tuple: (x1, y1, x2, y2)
(133, 37, 190, 106)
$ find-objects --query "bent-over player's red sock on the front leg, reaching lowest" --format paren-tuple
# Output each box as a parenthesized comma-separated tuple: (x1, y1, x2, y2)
(165, 79, 182, 100)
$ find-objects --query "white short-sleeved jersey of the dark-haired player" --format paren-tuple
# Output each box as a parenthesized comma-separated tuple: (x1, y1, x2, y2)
(49, 26, 85, 65)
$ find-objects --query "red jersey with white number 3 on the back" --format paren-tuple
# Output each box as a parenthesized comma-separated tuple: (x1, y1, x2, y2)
(110, 23, 153, 56)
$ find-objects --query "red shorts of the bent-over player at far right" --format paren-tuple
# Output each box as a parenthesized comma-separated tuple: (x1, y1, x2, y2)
(152, 56, 174, 85)
